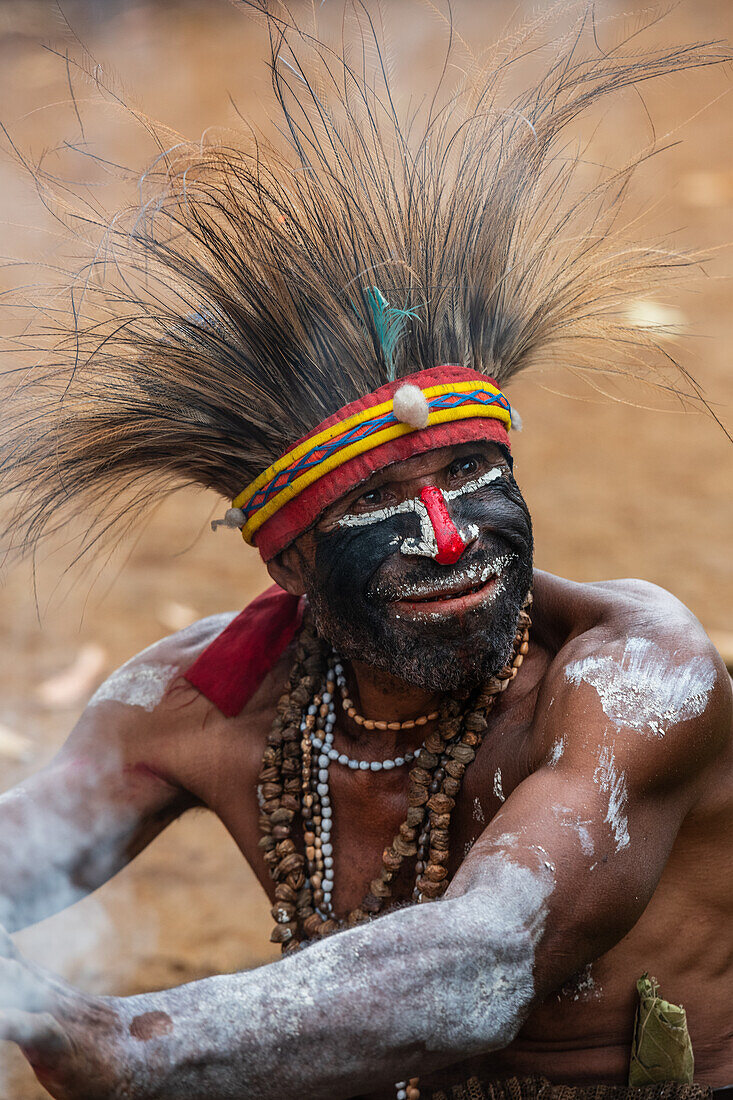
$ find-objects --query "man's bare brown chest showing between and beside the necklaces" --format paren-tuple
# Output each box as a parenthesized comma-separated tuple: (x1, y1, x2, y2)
(186, 707, 532, 917)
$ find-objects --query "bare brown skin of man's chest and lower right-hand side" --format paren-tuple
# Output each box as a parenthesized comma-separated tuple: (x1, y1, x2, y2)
(158, 664, 730, 1079)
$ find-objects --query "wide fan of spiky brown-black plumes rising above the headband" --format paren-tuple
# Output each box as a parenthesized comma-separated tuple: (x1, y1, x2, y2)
(1, 0, 729, 558)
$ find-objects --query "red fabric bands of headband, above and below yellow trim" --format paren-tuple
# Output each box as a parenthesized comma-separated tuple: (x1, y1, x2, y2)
(254, 366, 511, 561)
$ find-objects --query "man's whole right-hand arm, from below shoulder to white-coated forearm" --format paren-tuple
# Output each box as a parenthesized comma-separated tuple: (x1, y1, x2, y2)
(4, 645, 730, 1100)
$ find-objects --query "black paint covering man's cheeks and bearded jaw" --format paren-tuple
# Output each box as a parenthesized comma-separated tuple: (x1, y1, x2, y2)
(297, 471, 533, 691)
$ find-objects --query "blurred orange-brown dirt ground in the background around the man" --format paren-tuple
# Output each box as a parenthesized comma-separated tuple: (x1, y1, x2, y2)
(0, 0, 733, 1100)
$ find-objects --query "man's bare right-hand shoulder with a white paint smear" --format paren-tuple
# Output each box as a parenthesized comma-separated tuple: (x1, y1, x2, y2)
(530, 574, 733, 787)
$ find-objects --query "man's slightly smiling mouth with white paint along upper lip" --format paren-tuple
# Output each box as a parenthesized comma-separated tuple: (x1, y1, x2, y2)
(390, 554, 515, 618)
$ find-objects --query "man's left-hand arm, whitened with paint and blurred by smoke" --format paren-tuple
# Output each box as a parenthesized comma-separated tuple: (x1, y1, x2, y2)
(0, 639, 198, 931)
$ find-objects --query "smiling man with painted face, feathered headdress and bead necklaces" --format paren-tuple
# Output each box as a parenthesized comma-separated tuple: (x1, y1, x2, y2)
(0, 2, 733, 1100)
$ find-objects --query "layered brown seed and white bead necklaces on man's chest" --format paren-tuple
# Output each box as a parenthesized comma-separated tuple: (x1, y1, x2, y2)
(258, 594, 532, 1100)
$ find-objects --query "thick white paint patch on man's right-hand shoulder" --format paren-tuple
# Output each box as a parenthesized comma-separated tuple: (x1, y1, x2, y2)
(565, 638, 715, 737)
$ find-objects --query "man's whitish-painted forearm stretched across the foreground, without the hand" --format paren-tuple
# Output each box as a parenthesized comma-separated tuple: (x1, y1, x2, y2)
(116, 857, 551, 1100)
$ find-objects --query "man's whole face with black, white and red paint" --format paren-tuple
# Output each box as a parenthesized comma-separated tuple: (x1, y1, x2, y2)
(274, 443, 533, 691)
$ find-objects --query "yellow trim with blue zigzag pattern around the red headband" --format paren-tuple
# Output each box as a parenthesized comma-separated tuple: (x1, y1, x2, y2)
(232, 372, 516, 545)
